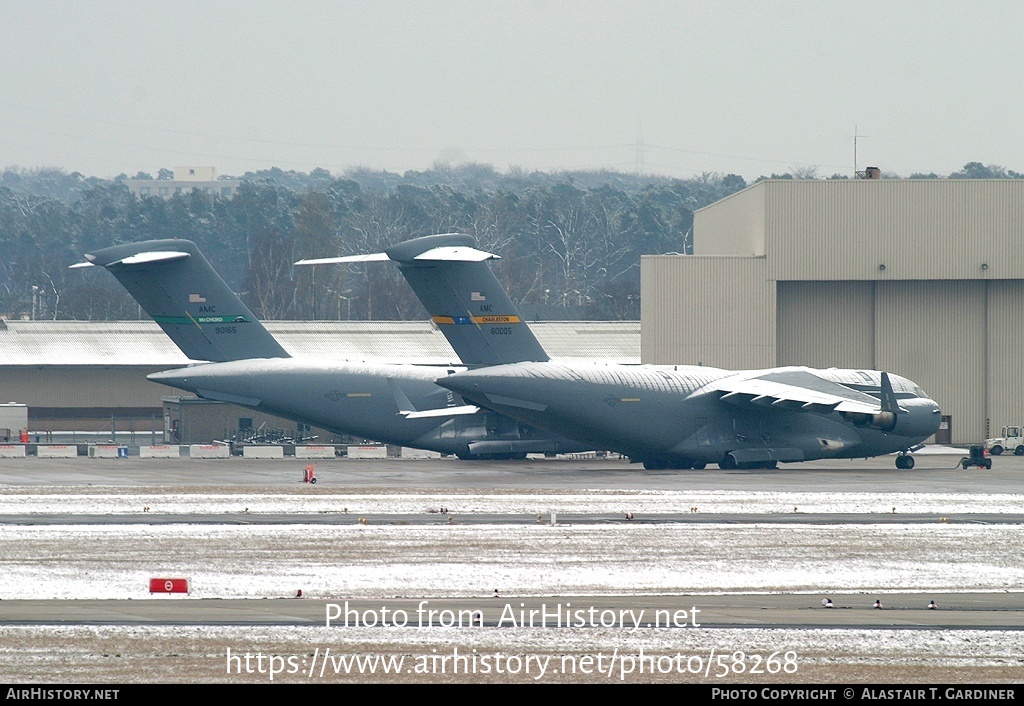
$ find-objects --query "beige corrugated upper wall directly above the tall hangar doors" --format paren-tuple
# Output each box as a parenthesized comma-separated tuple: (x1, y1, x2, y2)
(765, 179, 1024, 280)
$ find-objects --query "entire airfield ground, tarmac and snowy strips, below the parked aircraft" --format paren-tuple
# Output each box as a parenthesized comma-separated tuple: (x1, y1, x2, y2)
(0, 454, 1024, 682)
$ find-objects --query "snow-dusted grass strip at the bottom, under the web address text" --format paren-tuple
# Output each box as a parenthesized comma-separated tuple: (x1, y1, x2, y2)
(0, 625, 1024, 683)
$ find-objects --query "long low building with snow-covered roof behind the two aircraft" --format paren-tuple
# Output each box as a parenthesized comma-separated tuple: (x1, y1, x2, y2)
(0, 320, 640, 443)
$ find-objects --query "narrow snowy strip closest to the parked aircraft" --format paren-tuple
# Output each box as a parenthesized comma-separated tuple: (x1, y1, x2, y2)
(6, 487, 1024, 515)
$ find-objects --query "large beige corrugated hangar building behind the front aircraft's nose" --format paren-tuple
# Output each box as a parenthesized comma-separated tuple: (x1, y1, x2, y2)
(641, 179, 1024, 444)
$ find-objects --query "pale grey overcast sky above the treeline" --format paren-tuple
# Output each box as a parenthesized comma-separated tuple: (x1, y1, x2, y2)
(0, 0, 1024, 178)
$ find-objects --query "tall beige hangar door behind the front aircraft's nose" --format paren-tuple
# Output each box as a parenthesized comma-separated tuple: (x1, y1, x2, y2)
(776, 280, 987, 444)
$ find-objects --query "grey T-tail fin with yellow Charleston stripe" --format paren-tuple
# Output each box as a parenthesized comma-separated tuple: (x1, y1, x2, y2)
(296, 233, 548, 366)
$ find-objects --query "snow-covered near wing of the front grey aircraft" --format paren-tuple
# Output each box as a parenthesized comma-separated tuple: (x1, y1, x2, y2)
(714, 369, 888, 414)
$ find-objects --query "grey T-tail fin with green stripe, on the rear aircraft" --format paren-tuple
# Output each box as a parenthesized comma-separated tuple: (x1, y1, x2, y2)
(72, 240, 290, 363)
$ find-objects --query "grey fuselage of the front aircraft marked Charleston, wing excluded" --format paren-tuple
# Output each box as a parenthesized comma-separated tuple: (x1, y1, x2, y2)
(438, 362, 940, 467)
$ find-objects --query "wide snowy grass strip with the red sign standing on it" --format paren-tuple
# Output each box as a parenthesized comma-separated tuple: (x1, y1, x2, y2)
(0, 523, 1024, 599)
